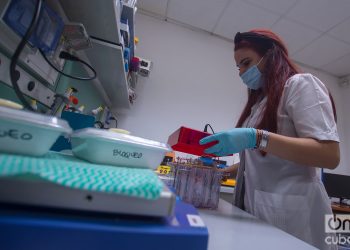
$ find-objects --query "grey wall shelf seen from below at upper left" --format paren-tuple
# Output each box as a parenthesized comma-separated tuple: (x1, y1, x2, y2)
(60, 0, 133, 114)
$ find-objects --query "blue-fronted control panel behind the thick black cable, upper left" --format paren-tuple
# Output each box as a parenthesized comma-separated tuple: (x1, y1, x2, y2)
(0, 0, 64, 86)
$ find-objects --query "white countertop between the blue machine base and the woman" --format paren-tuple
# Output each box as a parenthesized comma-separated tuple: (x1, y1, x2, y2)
(199, 199, 316, 250)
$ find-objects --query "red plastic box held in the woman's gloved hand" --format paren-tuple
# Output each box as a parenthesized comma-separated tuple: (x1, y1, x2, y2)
(168, 127, 217, 157)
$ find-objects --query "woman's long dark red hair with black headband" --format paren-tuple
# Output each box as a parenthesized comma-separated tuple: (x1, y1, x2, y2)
(234, 29, 336, 133)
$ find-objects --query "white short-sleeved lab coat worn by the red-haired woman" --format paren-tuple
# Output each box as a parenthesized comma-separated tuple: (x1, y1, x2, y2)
(235, 74, 339, 249)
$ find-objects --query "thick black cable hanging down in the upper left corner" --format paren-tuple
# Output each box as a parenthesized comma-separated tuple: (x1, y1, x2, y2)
(10, 0, 42, 111)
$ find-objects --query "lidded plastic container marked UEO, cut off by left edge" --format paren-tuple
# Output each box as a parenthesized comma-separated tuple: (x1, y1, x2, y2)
(0, 106, 72, 156)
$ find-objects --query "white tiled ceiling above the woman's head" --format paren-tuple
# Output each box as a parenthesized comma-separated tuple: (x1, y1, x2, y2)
(138, 0, 350, 77)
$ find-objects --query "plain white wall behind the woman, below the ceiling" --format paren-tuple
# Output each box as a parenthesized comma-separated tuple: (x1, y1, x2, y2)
(118, 14, 350, 172)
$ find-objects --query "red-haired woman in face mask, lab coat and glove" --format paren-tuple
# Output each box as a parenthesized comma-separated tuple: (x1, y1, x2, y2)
(200, 30, 340, 249)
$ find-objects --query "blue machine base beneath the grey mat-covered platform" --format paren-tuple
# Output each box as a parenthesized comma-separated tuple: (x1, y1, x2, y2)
(0, 197, 208, 250)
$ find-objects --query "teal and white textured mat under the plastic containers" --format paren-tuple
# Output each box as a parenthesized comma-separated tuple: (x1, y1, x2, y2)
(0, 152, 163, 200)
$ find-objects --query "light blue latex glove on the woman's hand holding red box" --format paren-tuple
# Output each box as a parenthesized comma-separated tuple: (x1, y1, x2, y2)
(199, 128, 256, 156)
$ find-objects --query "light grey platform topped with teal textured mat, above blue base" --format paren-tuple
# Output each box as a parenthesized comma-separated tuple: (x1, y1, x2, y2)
(0, 152, 175, 217)
